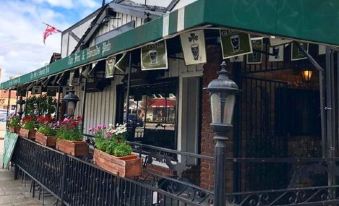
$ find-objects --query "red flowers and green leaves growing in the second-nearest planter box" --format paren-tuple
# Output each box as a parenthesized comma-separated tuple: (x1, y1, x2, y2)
(56, 117, 83, 141)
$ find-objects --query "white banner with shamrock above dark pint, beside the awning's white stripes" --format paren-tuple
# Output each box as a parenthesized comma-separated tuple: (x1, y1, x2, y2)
(180, 30, 207, 65)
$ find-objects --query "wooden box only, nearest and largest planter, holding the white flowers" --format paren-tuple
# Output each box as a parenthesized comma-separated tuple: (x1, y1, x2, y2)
(93, 149, 141, 177)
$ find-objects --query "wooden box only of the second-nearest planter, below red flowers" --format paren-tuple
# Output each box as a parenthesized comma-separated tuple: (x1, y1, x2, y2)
(56, 140, 88, 157)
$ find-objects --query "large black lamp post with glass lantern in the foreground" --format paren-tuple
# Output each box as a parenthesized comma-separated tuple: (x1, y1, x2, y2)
(207, 61, 239, 206)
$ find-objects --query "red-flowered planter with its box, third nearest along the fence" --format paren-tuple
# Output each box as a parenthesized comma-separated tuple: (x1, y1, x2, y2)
(35, 115, 56, 147)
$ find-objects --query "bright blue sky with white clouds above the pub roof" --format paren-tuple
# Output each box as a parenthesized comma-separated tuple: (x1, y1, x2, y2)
(0, 0, 102, 81)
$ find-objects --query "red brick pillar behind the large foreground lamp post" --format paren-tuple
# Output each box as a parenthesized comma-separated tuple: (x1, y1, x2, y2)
(200, 45, 233, 191)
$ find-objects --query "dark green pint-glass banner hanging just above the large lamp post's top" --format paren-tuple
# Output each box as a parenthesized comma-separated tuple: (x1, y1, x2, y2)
(220, 30, 252, 59)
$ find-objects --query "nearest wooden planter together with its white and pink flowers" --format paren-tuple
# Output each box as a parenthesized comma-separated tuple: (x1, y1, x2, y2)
(90, 125, 141, 177)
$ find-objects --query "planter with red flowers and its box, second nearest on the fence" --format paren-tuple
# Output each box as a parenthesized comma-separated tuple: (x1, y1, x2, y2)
(56, 117, 88, 157)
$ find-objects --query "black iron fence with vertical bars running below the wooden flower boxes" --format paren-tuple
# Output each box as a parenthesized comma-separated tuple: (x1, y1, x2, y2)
(12, 138, 207, 206)
